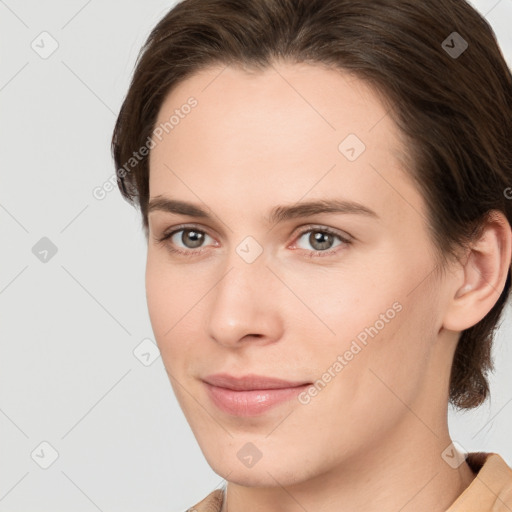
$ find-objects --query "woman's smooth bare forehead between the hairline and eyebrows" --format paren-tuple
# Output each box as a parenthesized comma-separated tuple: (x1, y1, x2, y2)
(150, 63, 420, 224)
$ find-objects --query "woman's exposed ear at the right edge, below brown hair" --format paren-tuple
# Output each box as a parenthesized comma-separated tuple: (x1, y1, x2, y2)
(443, 210, 512, 331)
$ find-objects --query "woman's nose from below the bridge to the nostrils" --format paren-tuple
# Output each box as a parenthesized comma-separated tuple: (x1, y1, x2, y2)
(208, 254, 283, 348)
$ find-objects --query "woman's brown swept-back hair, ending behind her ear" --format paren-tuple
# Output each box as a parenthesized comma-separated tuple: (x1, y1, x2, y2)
(112, 0, 512, 408)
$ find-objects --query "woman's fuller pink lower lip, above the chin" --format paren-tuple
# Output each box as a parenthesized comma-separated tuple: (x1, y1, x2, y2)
(205, 382, 311, 416)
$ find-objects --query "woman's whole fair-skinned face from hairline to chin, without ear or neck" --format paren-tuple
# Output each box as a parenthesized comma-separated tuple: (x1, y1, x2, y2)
(146, 63, 449, 486)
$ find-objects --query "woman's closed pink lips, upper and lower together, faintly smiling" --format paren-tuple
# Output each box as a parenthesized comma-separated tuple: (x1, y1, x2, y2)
(203, 374, 312, 416)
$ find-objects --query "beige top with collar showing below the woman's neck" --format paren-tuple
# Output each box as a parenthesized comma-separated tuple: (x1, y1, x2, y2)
(187, 452, 512, 512)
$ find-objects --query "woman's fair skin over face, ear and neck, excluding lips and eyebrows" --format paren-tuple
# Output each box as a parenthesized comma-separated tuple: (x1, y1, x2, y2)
(146, 62, 511, 512)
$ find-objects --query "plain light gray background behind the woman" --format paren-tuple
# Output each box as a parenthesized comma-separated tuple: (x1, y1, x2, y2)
(0, 0, 512, 512)
